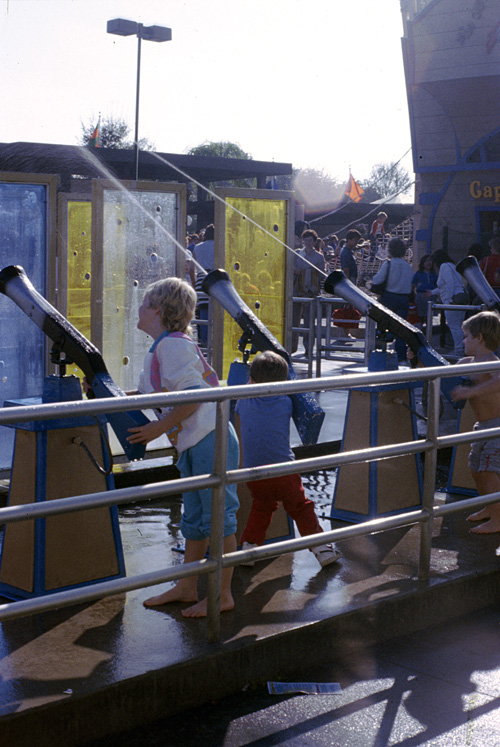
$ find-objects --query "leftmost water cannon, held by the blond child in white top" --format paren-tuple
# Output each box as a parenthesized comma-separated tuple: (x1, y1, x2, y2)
(0, 265, 149, 461)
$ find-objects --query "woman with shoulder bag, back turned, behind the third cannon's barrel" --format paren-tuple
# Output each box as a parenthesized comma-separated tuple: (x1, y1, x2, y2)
(371, 238, 413, 361)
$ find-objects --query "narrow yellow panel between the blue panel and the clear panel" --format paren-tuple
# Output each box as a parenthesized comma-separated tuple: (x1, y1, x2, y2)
(67, 201, 92, 376)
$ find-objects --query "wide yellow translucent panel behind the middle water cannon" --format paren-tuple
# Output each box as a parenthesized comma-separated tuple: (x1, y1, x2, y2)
(223, 197, 287, 378)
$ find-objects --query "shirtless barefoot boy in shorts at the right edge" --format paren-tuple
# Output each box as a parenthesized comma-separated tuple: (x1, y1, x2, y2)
(452, 311, 500, 534)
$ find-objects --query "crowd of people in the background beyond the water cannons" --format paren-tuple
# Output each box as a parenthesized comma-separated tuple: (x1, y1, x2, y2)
(185, 219, 500, 361)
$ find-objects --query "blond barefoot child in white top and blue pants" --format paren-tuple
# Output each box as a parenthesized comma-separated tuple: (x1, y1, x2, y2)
(128, 277, 239, 617)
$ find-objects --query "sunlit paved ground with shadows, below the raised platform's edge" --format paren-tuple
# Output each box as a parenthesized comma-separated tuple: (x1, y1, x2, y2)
(86, 606, 500, 747)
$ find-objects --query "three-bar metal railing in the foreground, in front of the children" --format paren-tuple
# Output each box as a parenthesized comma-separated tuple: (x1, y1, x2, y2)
(0, 362, 500, 641)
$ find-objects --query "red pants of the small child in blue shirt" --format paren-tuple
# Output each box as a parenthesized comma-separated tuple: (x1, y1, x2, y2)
(240, 475, 323, 545)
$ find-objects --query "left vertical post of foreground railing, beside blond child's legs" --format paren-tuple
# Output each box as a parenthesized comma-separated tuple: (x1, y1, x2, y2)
(207, 400, 230, 643)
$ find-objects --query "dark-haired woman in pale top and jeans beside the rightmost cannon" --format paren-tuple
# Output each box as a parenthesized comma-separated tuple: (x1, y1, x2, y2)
(427, 249, 470, 358)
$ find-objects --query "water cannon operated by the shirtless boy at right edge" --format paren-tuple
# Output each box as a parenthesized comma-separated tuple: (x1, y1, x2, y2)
(324, 270, 470, 409)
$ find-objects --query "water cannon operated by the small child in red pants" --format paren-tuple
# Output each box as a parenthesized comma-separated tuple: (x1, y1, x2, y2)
(201, 270, 325, 445)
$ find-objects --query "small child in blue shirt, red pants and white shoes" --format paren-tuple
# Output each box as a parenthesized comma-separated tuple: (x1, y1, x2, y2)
(236, 350, 341, 567)
